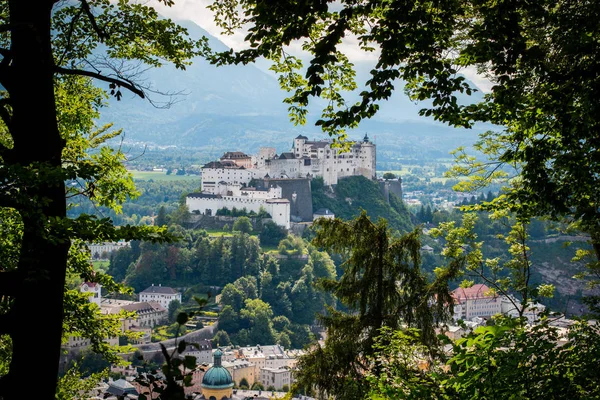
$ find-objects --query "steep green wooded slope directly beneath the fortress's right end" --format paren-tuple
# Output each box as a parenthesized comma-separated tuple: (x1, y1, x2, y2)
(311, 176, 413, 232)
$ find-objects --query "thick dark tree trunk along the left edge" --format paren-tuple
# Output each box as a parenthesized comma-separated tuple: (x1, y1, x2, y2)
(0, 0, 70, 400)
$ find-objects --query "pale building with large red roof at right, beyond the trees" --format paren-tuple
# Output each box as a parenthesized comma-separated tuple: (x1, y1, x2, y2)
(452, 284, 502, 320)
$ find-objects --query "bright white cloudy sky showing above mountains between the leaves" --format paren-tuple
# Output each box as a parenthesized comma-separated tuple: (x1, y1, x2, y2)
(149, 0, 492, 93)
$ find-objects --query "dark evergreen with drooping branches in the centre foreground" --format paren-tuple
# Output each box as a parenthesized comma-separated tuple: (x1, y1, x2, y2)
(296, 211, 457, 399)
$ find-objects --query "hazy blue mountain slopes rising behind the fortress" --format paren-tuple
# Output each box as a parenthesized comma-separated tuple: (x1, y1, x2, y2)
(101, 21, 490, 159)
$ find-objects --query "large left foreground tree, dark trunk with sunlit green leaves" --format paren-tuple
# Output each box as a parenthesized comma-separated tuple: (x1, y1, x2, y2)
(0, 0, 204, 399)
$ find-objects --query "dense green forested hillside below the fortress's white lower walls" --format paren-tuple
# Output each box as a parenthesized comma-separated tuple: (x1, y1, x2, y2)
(108, 225, 336, 348)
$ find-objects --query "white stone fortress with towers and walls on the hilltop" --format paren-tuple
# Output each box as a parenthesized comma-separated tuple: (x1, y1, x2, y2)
(186, 135, 376, 229)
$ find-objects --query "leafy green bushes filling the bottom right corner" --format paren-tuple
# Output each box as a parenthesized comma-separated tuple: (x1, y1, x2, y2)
(367, 319, 600, 400)
